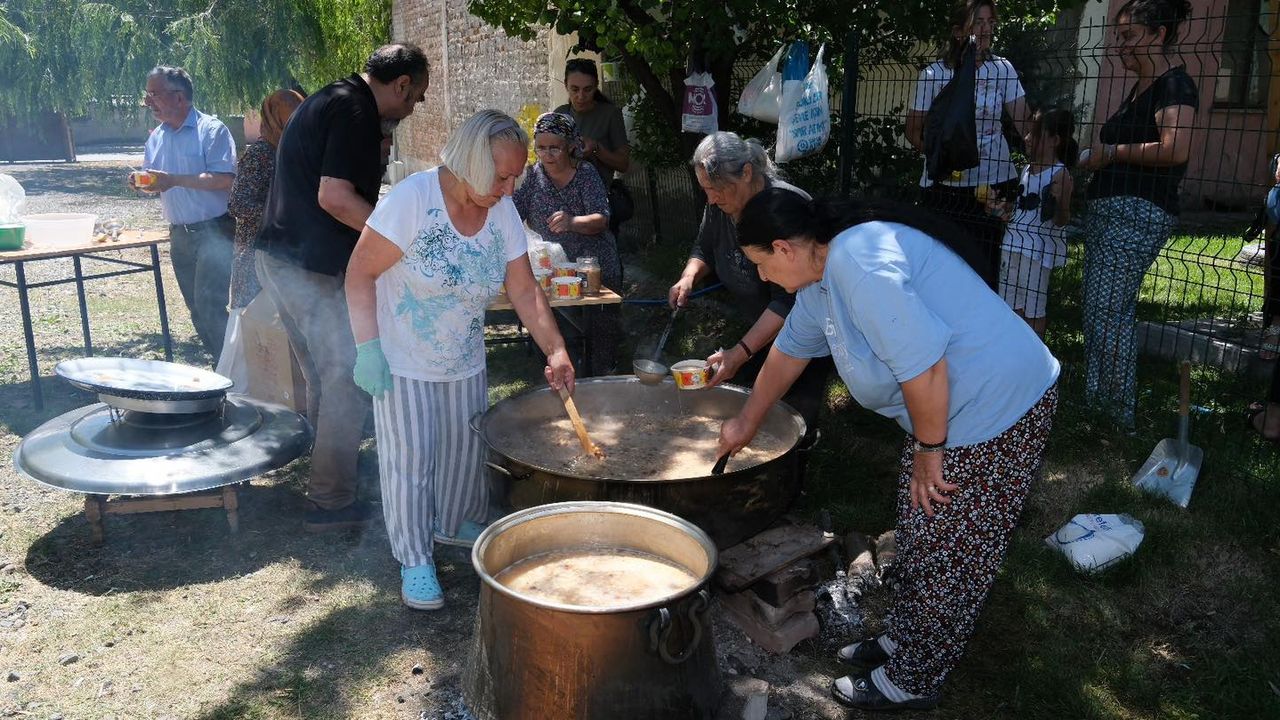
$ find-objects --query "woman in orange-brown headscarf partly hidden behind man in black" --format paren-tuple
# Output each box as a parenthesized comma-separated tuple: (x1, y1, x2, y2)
(218, 90, 303, 389)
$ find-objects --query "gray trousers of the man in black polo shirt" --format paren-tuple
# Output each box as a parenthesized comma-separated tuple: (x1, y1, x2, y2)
(252, 252, 369, 510)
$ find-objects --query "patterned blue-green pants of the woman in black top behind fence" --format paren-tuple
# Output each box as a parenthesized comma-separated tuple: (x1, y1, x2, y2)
(1084, 197, 1175, 428)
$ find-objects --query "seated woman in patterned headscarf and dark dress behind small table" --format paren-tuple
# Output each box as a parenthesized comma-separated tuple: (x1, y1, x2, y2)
(515, 113, 622, 374)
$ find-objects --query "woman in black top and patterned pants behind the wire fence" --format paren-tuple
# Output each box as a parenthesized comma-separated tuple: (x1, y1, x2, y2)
(1080, 0, 1199, 428)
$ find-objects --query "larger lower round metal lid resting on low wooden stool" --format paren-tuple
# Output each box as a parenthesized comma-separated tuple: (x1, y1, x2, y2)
(13, 395, 311, 495)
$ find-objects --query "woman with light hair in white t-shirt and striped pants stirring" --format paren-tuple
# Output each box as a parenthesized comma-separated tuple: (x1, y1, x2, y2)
(346, 110, 573, 610)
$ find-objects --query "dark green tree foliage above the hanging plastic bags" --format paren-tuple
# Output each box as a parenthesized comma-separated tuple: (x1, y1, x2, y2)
(470, 0, 1083, 170)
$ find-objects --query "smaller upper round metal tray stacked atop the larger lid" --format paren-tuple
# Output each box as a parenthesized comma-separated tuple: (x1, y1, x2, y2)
(54, 357, 232, 400)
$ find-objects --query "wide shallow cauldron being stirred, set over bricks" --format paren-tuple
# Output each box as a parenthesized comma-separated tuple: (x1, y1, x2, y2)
(472, 375, 805, 548)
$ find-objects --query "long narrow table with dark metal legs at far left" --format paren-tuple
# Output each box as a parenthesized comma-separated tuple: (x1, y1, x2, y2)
(0, 231, 173, 410)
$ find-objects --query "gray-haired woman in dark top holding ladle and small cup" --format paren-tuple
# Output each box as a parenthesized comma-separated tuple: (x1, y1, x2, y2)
(667, 132, 832, 445)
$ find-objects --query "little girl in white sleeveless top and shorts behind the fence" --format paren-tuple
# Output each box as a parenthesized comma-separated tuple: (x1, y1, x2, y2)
(1000, 109, 1078, 338)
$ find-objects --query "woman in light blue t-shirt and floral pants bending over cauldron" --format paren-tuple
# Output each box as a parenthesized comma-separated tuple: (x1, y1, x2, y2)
(721, 190, 1059, 710)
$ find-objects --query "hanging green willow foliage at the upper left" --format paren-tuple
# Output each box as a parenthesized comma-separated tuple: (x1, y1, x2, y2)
(0, 0, 392, 119)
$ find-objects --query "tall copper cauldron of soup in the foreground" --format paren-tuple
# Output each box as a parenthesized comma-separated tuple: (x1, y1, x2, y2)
(462, 502, 721, 720)
